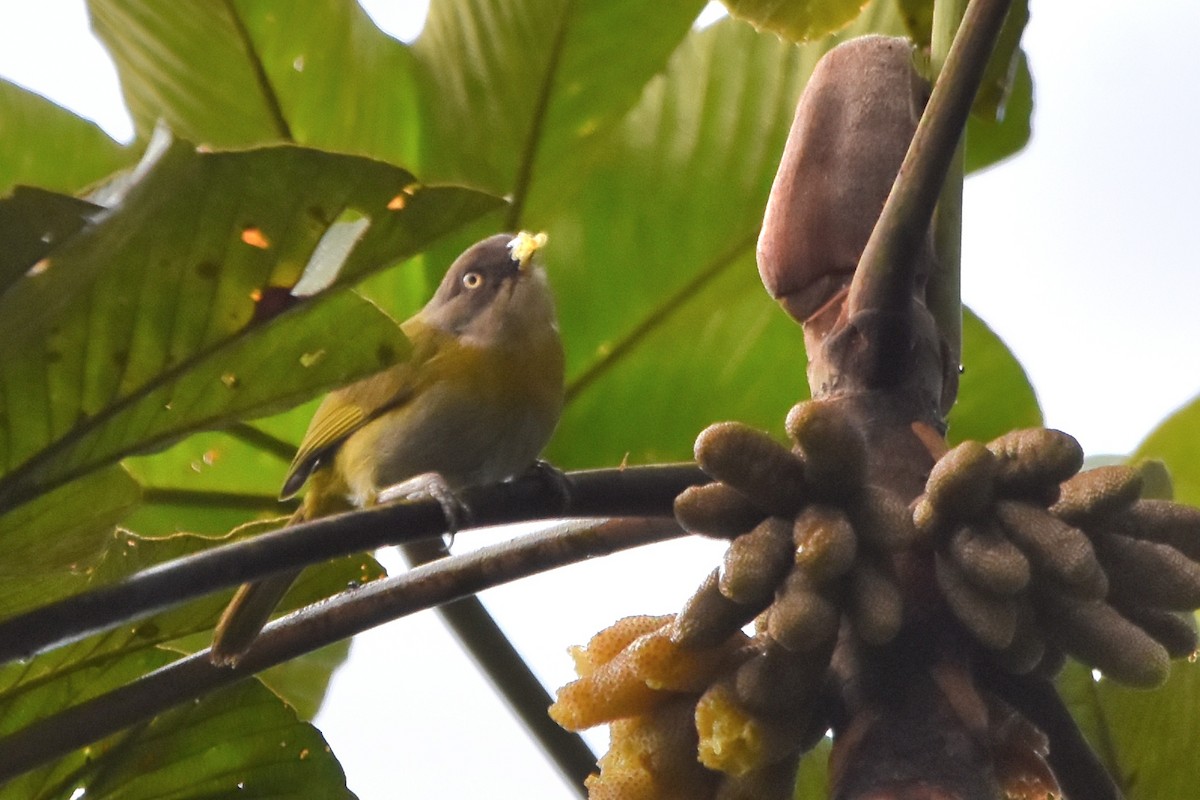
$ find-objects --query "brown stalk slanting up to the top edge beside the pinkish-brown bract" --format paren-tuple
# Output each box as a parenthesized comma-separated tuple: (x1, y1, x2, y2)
(850, 0, 1012, 314)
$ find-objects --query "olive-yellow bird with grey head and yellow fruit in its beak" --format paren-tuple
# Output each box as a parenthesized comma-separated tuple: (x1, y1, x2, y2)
(210, 233, 563, 666)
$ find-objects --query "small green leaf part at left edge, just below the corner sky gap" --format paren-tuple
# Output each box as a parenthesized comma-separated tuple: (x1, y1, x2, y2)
(0, 79, 137, 196)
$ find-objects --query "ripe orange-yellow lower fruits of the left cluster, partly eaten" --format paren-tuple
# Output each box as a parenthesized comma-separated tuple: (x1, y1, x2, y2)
(550, 615, 829, 800)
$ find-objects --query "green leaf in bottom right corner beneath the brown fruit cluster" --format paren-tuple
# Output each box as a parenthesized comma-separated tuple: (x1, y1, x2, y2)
(1057, 661, 1200, 800)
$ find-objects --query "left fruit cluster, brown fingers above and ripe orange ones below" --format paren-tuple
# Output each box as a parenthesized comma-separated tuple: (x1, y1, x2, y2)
(551, 402, 902, 800)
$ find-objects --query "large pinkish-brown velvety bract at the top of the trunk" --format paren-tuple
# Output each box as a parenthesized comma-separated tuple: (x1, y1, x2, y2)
(758, 36, 932, 323)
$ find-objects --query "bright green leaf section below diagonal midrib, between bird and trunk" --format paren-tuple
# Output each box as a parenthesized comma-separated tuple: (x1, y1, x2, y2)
(548, 247, 808, 468)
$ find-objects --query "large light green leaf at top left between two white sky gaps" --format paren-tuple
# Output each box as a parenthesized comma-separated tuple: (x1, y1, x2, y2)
(88, 0, 419, 164)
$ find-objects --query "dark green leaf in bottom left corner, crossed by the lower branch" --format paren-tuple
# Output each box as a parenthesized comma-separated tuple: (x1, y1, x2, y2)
(0, 649, 353, 800)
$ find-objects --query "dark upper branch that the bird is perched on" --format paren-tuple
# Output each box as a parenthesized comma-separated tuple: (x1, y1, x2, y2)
(0, 464, 709, 663)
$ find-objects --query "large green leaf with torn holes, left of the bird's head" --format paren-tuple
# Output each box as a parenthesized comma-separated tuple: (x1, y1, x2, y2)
(0, 137, 498, 506)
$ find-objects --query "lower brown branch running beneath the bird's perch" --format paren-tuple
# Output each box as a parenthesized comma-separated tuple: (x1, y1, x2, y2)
(0, 515, 684, 782)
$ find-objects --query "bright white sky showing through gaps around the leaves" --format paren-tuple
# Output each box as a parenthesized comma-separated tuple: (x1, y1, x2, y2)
(0, 0, 1200, 800)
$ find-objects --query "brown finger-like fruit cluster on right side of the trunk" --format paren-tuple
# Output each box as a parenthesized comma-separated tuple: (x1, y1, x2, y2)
(913, 428, 1200, 686)
